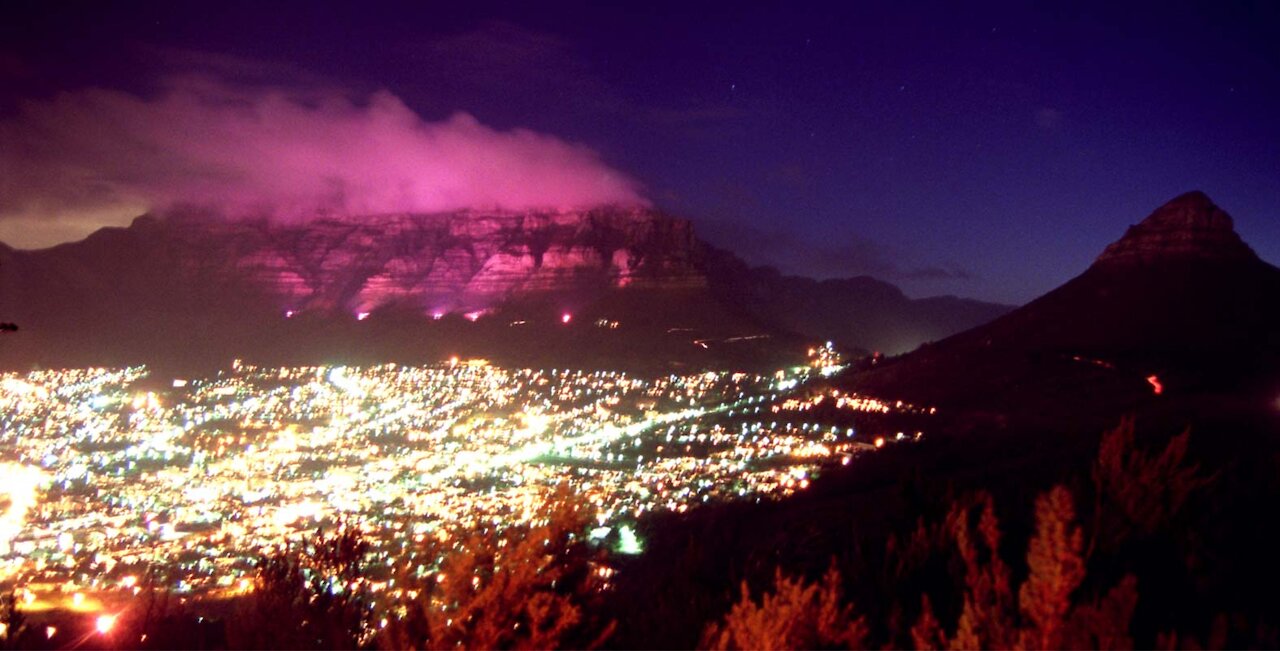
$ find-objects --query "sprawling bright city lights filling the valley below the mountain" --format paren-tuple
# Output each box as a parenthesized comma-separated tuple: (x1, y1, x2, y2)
(0, 358, 921, 606)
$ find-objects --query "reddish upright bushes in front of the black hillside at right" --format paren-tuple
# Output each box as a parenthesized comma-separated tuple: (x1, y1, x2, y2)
(704, 421, 1208, 651)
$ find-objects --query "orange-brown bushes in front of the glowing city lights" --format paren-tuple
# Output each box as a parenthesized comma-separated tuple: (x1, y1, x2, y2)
(228, 487, 611, 650)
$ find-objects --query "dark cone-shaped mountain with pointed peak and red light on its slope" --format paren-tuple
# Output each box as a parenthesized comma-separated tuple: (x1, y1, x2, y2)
(846, 192, 1280, 425)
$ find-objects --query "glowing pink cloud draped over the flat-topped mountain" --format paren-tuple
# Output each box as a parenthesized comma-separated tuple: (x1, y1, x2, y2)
(0, 77, 645, 245)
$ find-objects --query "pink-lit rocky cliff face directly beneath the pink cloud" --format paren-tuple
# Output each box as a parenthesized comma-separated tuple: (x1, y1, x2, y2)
(116, 210, 705, 316)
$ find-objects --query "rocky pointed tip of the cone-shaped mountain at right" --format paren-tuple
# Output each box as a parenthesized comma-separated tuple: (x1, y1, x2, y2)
(1096, 191, 1257, 265)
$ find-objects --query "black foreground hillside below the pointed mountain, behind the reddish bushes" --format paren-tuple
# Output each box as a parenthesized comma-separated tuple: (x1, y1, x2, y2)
(609, 388, 1280, 648)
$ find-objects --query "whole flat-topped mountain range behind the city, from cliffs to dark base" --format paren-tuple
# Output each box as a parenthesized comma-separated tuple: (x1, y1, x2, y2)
(0, 207, 1007, 368)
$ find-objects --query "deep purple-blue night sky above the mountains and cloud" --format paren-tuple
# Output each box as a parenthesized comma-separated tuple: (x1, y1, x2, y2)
(0, 1, 1280, 303)
